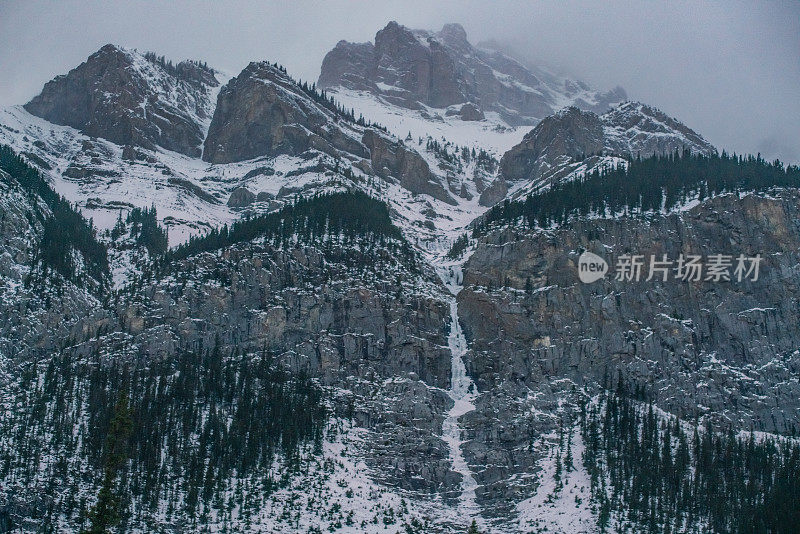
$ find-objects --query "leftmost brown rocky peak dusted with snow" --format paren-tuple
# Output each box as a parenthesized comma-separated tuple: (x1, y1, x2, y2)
(25, 45, 219, 156)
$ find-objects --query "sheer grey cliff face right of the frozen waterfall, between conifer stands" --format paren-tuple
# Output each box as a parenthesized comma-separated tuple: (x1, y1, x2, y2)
(458, 191, 800, 510)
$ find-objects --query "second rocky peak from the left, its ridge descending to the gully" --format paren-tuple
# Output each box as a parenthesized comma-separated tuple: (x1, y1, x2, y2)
(203, 59, 462, 204)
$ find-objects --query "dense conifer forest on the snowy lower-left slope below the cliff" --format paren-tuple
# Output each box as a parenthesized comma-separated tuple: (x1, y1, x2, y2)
(0, 343, 328, 532)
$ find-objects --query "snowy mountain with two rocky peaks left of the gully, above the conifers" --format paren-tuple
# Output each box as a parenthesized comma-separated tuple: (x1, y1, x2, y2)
(0, 45, 483, 244)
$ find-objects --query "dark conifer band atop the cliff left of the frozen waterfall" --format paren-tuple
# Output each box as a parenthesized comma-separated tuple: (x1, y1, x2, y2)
(165, 191, 413, 261)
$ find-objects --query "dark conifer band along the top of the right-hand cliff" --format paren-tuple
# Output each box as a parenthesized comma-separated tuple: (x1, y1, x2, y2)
(475, 150, 800, 234)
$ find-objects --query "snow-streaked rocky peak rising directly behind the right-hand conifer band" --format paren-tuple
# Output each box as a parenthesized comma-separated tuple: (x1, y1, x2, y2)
(490, 102, 716, 205)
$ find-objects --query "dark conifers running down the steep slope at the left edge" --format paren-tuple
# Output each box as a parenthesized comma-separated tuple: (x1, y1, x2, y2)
(0, 145, 109, 287)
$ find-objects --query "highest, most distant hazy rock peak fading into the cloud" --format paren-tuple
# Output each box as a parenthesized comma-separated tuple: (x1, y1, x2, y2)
(319, 22, 626, 126)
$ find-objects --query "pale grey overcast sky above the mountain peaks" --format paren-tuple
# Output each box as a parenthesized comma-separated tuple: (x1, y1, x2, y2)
(0, 0, 800, 163)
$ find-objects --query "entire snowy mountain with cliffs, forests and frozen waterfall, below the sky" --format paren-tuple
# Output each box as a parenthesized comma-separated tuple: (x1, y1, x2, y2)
(0, 22, 800, 534)
